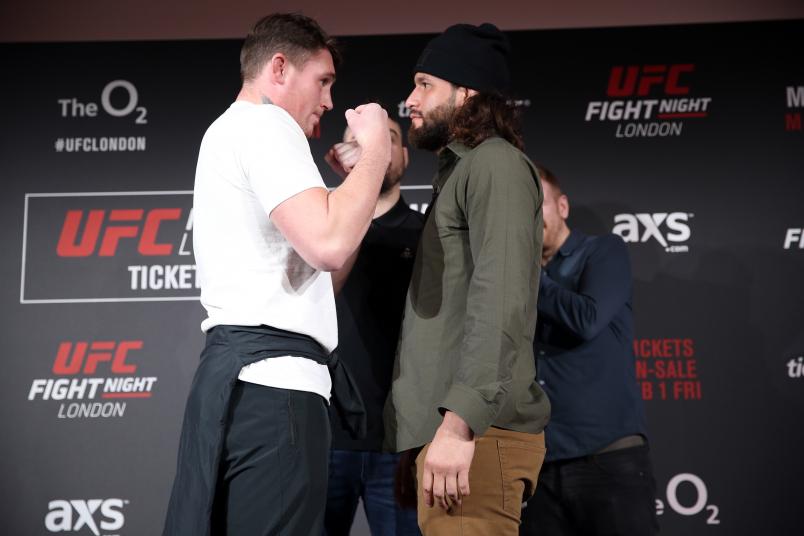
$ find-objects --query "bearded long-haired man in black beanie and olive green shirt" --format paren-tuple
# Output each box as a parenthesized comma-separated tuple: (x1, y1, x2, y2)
(385, 24, 550, 536)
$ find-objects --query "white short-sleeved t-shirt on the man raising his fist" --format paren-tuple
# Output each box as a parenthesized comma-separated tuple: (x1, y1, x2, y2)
(193, 101, 338, 399)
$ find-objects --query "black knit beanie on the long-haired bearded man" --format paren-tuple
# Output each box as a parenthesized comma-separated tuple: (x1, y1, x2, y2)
(413, 22, 511, 93)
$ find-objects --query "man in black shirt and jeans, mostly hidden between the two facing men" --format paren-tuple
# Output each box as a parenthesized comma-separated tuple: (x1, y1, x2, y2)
(324, 118, 424, 536)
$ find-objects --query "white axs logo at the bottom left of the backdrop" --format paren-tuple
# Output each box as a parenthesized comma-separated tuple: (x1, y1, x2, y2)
(45, 499, 128, 536)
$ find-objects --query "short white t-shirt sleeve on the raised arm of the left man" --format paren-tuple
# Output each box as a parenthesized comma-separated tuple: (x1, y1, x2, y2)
(241, 110, 326, 214)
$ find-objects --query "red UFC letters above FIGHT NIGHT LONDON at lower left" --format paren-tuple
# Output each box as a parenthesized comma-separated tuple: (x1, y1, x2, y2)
(53, 341, 142, 375)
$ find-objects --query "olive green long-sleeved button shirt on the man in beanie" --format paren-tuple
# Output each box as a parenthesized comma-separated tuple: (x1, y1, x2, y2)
(384, 138, 550, 451)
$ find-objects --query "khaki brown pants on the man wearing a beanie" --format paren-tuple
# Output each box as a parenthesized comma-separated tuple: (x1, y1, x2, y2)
(416, 428, 545, 536)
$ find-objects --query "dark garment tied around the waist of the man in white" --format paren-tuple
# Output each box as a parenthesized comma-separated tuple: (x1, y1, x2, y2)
(163, 326, 367, 536)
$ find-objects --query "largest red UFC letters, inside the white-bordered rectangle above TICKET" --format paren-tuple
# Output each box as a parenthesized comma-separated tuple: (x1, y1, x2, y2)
(56, 208, 181, 257)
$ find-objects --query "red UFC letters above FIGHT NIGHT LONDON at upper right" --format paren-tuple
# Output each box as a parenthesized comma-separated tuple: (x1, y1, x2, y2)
(607, 63, 695, 97)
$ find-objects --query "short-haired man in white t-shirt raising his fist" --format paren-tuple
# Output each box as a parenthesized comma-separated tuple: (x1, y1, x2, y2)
(164, 14, 391, 536)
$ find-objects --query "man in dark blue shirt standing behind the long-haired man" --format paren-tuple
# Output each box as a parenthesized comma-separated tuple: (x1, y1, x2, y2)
(520, 168, 658, 536)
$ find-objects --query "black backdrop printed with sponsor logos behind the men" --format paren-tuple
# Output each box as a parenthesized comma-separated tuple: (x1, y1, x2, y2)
(0, 21, 804, 535)
